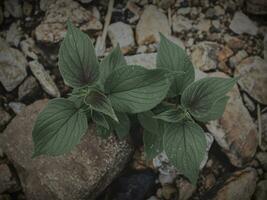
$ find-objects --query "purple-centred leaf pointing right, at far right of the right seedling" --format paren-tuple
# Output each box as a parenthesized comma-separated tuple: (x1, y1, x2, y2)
(181, 77, 236, 119)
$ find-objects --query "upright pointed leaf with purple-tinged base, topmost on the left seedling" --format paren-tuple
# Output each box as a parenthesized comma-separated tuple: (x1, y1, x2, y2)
(58, 21, 99, 88)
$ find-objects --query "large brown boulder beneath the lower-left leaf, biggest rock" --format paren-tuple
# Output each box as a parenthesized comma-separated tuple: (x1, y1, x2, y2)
(1, 100, 132, 200)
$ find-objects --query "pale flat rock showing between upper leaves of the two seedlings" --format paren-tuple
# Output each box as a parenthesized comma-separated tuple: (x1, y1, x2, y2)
(125, 53, 156, 69)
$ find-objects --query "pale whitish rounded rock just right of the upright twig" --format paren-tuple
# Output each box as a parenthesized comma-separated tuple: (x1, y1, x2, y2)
(108, 22, 135, 54)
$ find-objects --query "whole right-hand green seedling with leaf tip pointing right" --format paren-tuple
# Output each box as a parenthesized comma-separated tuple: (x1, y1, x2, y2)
(138, 34, 236, 184)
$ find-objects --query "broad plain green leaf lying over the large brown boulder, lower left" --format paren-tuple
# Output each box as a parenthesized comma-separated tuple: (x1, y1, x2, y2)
(32, 98, 88, 157)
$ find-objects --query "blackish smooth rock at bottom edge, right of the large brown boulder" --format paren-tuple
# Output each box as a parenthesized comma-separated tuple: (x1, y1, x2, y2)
(108, 171, 157, 200)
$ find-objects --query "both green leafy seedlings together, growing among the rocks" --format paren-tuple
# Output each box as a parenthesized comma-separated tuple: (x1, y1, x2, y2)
(32, 22, 236, 183)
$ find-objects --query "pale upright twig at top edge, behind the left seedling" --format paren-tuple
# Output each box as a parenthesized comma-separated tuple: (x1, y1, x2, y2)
(95, 0, 114, 56)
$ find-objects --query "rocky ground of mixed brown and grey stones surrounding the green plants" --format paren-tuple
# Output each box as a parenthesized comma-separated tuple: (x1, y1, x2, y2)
(0, 0, 267, 200)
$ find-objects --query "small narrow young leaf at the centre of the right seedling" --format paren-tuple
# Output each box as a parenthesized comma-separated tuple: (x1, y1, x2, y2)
(154, 108, 185, 123)
